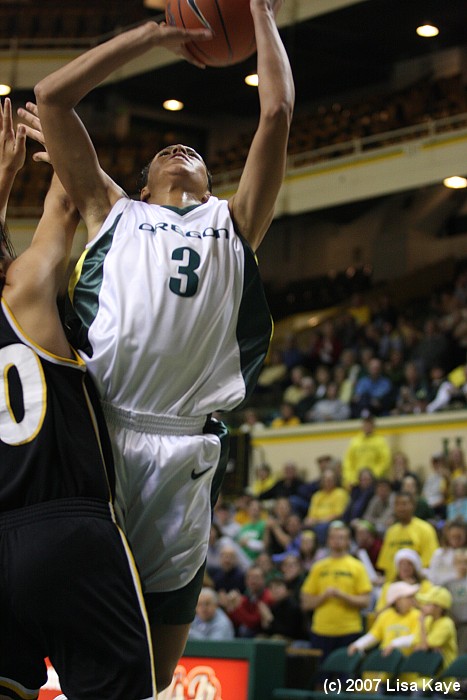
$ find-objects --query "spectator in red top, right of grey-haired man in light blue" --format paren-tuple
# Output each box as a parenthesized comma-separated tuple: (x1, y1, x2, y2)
(219, 565, 273, 638)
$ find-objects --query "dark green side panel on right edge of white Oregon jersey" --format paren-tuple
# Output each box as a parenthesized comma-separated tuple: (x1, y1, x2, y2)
(236, 236, 273, 408)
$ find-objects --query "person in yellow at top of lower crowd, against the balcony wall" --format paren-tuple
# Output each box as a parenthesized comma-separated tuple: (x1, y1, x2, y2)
(343, 414, 391, 488)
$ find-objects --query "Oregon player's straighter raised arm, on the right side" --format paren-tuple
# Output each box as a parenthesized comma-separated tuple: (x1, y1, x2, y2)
(230, 0, 295, 250)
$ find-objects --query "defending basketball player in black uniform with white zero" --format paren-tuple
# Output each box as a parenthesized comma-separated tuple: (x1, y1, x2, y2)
(0, 99, 155, 700)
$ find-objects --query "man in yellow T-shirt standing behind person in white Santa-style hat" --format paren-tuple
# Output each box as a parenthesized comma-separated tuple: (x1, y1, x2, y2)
(376, 492, 439, 581)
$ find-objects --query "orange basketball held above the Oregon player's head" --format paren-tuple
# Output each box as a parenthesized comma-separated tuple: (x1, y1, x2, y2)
(165, 0, 256, 67)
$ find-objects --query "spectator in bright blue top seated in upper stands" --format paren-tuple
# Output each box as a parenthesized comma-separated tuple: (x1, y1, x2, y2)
(350, 357, 393, 418)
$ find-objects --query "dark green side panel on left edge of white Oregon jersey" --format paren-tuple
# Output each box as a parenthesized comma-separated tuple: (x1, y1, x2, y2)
(65, 214, 122, 357)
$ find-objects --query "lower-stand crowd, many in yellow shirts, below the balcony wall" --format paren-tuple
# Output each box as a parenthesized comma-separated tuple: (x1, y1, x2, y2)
(190, 434, 467, 688)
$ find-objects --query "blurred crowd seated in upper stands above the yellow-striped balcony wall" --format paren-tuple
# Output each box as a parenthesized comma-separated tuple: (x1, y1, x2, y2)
(238, 265, 467, 431)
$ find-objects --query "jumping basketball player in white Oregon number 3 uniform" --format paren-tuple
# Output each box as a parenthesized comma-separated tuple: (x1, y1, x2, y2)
(24, 0, 294, 689)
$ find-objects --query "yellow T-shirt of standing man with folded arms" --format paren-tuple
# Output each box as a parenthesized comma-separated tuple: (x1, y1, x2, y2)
(301, 554, 372, 637)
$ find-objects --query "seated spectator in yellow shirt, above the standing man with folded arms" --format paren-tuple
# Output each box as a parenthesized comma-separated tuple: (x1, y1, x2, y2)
(303, 469, 349, 545)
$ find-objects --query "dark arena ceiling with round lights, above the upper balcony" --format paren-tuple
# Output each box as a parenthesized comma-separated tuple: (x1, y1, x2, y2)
(0, 0, 467, 120)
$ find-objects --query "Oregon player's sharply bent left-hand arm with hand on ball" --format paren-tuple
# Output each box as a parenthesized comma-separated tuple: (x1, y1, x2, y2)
(35, 22, 211, 238)
